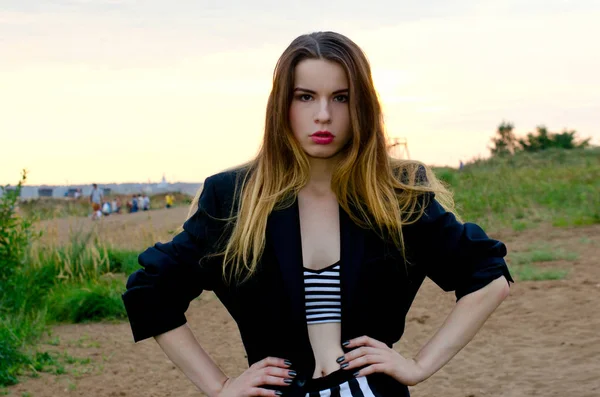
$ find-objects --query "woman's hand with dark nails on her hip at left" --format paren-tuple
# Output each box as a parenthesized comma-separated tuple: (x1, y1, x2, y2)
(215, 357, 296, 397)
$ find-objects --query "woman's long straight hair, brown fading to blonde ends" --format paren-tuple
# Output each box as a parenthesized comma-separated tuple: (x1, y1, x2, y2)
(190, 32, 454, 282)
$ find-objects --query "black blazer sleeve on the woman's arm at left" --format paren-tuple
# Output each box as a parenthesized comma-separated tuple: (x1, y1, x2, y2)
(123, 177, 221, 342)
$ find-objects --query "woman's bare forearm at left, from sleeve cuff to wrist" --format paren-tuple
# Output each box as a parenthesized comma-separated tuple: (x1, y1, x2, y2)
(155, 324, 227, 396)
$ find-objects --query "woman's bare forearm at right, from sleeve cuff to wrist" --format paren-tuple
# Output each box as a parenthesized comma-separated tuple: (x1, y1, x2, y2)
(415, 276, 510, 380)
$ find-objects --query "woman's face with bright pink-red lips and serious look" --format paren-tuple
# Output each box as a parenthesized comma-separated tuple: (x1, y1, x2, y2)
(290, 59, 352, 159)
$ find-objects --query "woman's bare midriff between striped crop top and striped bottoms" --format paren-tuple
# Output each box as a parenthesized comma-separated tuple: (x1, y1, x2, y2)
(308, 322, 344, 378)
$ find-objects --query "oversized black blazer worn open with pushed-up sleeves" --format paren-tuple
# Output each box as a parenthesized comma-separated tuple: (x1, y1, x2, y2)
(123, 167, 512, 395)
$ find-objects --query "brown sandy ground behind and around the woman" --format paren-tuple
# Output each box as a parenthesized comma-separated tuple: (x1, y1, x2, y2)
(9, 209, 600, 397)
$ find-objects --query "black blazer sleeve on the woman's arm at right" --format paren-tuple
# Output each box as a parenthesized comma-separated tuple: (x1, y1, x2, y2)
(413, 193, 514, 300)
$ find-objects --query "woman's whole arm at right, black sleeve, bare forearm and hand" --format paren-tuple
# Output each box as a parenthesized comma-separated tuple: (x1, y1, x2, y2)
(338, 189, 513, 386)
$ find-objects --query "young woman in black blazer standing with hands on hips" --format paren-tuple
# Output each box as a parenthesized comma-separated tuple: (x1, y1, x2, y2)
(123, 32, 512, 397)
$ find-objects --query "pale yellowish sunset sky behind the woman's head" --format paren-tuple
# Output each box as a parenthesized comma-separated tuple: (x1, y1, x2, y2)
(0, 0, 600, 185)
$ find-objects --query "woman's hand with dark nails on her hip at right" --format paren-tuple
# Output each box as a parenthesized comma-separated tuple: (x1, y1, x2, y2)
(337, 336, 428, 386)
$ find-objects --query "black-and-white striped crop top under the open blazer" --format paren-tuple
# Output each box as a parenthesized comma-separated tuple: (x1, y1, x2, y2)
(304, 262, 342, 324)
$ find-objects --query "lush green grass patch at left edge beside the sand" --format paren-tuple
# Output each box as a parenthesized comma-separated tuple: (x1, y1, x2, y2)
(0, 229, 139, 386)
